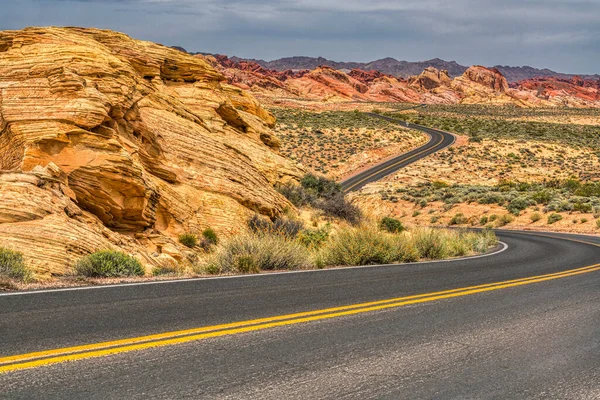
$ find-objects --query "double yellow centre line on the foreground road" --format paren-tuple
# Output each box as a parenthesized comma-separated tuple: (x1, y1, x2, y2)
(0, 264, 600, 373)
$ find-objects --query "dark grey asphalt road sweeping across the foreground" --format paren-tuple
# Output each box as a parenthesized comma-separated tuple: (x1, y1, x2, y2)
(0, 232, 600, 399)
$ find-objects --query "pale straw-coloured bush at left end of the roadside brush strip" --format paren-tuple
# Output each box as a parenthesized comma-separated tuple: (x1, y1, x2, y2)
(210, 233, 311, 273)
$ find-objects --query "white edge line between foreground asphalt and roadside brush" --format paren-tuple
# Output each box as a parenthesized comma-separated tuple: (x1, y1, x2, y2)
(0, 241, 508, 297)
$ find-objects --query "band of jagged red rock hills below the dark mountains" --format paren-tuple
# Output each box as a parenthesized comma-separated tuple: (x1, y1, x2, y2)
(211, 56, 600, 107)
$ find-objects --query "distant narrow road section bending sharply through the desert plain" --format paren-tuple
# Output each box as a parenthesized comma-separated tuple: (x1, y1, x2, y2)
(340, 113, 455, 193)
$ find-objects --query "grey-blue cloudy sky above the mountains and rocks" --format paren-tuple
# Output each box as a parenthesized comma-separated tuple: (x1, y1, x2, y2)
(0, 0, 600, 74)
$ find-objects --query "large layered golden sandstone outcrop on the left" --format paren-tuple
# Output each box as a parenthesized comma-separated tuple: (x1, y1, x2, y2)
(0, 28, 301, 274)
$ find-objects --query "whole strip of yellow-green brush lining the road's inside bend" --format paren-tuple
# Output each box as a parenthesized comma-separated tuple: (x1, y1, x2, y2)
(205, 224, 497, 274)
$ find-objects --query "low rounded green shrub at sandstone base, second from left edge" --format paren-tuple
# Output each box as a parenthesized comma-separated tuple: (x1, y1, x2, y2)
(75, 250, 144, 278)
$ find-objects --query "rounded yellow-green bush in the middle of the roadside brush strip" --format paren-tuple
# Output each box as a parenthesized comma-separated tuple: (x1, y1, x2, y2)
(321, 227, 419, 265)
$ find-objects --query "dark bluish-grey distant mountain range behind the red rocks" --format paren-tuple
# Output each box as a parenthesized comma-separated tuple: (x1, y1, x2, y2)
(226, 57, 600, 83)
